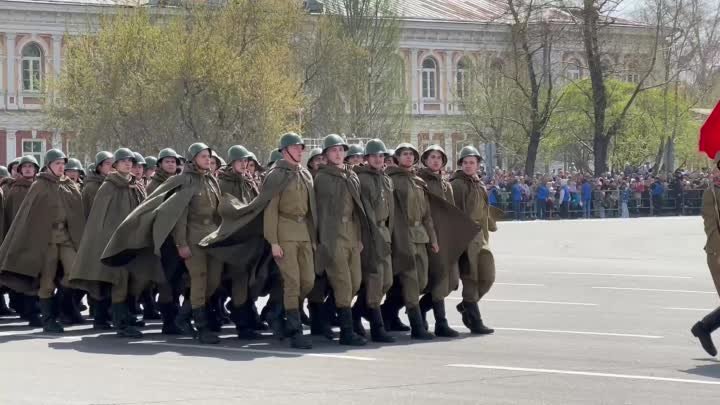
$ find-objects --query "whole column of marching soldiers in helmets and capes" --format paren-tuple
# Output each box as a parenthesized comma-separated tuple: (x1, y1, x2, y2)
(0, 133, 498, 349)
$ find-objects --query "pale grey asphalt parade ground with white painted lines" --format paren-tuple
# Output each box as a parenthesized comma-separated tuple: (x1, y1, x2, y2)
(0, 217, 720, 405)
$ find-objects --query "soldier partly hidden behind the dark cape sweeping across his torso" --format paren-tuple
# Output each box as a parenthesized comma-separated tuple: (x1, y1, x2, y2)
(218, 145, 260, 339)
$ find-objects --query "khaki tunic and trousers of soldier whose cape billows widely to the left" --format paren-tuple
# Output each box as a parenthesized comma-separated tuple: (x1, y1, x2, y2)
(172, 174, 223, 309)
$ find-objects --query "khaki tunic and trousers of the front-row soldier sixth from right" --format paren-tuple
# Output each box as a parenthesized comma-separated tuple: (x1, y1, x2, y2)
(263, 169, 315, 310)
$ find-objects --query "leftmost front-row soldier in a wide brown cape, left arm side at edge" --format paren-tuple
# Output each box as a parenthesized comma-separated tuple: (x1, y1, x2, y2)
(0, 149, 85, 333)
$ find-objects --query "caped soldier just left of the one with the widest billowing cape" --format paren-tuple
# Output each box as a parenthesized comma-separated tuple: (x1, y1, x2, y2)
(68, 148, 166, 338)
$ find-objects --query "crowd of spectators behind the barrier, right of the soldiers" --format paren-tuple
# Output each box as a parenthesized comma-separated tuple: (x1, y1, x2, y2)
(485, 166, 710, 220)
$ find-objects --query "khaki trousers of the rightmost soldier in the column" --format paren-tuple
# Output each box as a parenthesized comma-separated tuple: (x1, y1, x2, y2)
(460, 238, 495, 303)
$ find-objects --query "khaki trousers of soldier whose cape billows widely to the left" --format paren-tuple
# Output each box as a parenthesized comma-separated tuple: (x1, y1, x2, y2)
(185, 244, 223, 309)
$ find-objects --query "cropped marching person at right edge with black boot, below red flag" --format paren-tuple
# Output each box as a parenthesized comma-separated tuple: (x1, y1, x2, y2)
(690, 153, 720, 357)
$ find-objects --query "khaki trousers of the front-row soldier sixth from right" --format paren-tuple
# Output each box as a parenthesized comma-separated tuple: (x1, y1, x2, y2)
(275, 242, 315, 310)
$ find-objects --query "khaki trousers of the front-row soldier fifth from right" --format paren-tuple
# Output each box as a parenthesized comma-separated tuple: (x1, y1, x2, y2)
(326, 246, 362, 308)
